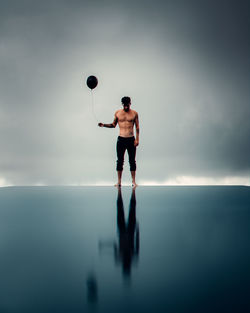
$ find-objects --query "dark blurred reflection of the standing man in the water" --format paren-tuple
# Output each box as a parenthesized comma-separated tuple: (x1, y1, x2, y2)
(114, 188, 139, 276)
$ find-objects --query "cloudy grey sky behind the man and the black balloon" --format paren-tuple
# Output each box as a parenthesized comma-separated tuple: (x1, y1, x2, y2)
(0, 0, 250, 186)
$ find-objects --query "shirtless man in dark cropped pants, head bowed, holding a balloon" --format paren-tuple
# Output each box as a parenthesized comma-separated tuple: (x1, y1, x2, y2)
(98, 97, 139, 187)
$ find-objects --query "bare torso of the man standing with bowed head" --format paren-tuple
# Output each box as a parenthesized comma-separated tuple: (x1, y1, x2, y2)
(115, 109, 137, 137)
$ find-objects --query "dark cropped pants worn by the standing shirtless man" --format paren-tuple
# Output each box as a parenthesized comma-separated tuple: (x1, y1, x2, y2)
(116, 136, 136, 171)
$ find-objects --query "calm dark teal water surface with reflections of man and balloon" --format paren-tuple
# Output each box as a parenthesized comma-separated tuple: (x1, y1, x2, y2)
(0, 187, 250, 313)
